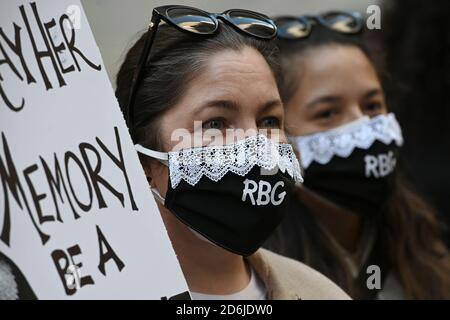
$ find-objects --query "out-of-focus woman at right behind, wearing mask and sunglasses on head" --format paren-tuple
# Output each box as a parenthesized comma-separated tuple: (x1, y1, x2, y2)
(267, 12, 450, 299)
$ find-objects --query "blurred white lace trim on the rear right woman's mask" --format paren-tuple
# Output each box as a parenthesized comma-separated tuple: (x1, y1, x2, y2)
(290, 113, 403, 169)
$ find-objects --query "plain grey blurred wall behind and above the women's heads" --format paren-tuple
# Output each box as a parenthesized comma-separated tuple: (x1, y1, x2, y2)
(81, 0, 379, 87)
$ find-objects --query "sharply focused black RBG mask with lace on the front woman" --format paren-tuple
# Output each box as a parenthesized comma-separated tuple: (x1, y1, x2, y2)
(137, 135, 302, 256)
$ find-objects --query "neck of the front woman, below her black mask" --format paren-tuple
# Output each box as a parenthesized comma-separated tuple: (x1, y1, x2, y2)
(160, 207, 250, 295)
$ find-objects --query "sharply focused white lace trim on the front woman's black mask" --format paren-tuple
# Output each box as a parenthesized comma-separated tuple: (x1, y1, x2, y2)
(169, 135, 303, 188)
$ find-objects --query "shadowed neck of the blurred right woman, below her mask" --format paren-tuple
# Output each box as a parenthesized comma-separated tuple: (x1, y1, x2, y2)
(298, 188, 362, 253)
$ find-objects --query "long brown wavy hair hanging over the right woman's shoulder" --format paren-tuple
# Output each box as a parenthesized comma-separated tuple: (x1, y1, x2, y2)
(379, 175, 450, 299)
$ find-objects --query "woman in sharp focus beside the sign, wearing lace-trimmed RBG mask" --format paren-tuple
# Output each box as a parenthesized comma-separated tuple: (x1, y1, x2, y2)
(116, 6, 347, 299)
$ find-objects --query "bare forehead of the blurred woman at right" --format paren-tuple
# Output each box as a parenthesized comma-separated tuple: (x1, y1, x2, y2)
(300, 45, 380, 94)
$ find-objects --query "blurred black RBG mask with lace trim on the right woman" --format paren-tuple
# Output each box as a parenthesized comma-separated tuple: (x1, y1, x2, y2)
(292, 114, 403, 216)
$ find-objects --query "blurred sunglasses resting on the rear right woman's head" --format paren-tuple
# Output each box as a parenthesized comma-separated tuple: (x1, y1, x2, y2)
(274, 11, 363, 40)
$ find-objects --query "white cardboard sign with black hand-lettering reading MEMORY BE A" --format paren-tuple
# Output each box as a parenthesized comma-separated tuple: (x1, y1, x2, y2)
(0, 0, 188, 299)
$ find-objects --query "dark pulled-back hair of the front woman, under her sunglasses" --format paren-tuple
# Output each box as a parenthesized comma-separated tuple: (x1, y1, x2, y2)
(116, 21, 280, 149)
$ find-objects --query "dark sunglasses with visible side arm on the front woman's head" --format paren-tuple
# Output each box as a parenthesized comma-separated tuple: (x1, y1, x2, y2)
(126, 5, 277, 132)
